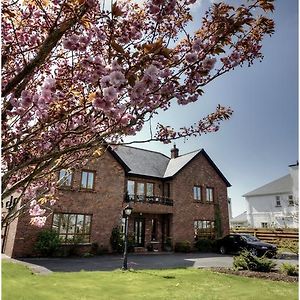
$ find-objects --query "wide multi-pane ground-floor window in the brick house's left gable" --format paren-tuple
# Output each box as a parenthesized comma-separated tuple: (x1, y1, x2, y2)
(52, 213, 92, 243)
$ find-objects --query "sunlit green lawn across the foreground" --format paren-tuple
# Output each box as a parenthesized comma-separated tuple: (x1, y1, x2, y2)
(2, 261, 298, 300)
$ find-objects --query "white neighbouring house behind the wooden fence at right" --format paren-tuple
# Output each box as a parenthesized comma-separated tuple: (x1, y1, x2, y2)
(243, 162, 299, 228)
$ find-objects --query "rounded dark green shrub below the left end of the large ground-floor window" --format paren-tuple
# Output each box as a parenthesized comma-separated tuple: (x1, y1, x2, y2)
(35, 229, 60, 256)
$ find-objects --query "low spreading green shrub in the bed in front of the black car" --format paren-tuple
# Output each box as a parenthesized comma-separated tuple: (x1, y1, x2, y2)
(233, 250, 276, 272)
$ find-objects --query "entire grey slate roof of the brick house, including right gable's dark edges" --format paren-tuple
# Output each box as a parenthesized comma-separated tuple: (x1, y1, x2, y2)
(111, 145, 231, 186)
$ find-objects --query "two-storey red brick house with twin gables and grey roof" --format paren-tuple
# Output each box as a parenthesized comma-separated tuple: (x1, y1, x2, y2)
(4, 146, 230, 257)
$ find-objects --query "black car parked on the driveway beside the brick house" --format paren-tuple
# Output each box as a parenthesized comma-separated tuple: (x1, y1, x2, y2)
(217, 234, 277, 257)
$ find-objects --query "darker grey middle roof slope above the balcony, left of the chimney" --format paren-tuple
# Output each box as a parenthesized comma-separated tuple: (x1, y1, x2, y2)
(113, 146, 170, 178)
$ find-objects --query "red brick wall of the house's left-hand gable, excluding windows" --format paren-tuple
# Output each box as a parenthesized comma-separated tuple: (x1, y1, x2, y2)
(12, 152, 125, 257)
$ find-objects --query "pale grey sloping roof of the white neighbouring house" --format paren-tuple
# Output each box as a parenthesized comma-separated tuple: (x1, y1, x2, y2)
(243, 174, 293, 197)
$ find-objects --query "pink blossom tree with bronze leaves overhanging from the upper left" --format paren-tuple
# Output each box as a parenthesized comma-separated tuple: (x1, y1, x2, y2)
(2, 0, 274, 226)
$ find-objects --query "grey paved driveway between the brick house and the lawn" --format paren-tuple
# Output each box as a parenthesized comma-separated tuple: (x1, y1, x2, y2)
(22, 253, 298, 272)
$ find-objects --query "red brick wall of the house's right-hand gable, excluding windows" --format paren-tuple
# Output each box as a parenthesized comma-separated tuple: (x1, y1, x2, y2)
(171, 154, 229, 243)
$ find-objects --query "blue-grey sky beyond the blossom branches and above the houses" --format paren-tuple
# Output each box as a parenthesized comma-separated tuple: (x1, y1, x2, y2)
(127, 0, 298, 217)
